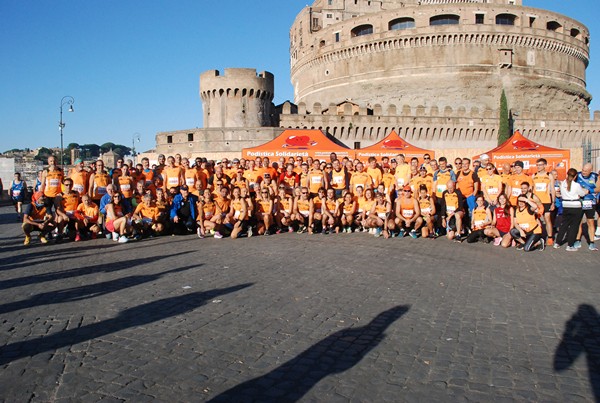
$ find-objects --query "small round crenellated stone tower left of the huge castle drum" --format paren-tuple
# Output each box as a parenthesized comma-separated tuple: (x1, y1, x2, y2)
(200, 68, 275, 128)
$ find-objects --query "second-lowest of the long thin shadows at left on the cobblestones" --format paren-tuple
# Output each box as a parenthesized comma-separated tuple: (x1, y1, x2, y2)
(0, 264, 202, 314)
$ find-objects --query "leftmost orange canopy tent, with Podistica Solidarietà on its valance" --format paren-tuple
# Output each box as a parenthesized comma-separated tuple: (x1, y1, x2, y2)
(242, 129, 354, 160)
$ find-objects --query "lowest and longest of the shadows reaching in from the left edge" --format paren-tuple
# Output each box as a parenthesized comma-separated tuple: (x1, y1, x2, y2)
(0, 283, 253, 365)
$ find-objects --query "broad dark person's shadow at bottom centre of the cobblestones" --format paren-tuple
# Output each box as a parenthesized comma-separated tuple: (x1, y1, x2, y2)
(210, 305, 410, 402)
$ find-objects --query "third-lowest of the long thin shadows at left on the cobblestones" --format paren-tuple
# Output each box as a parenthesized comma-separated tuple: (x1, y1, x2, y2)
(0, 252, 191, 290)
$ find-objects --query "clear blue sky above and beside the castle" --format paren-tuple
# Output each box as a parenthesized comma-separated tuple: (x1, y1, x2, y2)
(0, 0, 600, 152)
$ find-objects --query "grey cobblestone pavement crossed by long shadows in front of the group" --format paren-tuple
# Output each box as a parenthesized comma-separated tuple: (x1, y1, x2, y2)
(0, 207, 600, 402)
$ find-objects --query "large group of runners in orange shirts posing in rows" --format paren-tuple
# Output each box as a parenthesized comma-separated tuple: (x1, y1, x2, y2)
(9, 153, 600, 251)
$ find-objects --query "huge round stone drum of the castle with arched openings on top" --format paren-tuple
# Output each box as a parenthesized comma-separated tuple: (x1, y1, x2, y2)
(290, 0, 591, 115)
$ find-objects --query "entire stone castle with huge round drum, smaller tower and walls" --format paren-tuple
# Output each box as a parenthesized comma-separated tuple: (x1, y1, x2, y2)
(156, 0, 600, 166)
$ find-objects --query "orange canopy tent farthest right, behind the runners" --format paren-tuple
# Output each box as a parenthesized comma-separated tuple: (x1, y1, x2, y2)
(474, 130, 571, 179)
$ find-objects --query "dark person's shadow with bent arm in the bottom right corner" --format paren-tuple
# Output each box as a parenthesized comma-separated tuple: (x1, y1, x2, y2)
(554, 304, 600, 402)
